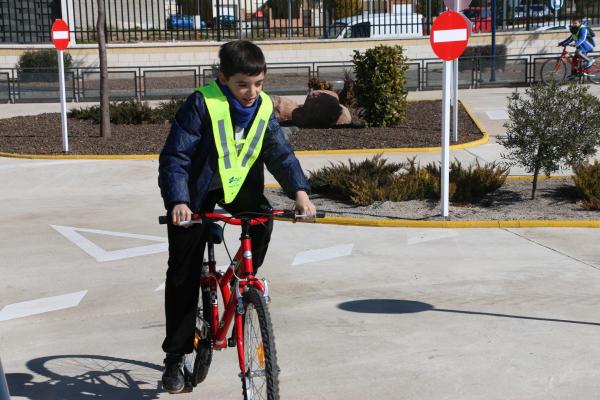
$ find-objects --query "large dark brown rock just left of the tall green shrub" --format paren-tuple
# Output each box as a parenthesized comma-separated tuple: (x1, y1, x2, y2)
(292, 90, 342, 128)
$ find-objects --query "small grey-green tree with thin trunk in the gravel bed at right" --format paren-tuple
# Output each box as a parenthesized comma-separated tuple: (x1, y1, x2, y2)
(500, 81, 600, 199)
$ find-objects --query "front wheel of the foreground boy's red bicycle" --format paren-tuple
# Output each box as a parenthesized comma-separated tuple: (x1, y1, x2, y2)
(242, 287, 279, 400)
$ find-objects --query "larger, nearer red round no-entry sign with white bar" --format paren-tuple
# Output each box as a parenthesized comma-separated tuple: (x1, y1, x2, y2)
(429, 11, 470, 61)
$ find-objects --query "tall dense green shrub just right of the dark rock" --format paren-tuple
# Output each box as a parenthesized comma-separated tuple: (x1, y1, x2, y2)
(352, 45, 408, 126)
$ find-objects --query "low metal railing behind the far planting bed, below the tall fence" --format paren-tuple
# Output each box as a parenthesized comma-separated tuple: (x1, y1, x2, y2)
(0, 49, 592, 103)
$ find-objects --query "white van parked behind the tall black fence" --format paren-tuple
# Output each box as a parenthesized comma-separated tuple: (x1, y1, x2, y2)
(323, 13, 423, 39)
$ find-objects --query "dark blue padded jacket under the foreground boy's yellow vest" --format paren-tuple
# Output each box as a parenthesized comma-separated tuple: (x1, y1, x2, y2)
(158, 92, 310, 212)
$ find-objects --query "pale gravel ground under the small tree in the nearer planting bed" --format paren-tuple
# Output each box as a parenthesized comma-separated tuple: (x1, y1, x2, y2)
(265, 178, 600, 221)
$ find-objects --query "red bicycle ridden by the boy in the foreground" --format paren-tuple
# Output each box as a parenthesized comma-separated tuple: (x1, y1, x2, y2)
(159, 210, 325, 400)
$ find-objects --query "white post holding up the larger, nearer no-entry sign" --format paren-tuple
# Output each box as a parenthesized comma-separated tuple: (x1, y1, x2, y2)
(440, 61, 452, 217)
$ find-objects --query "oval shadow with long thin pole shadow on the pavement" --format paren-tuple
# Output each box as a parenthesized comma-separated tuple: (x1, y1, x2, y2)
(338, 299, 600, 326)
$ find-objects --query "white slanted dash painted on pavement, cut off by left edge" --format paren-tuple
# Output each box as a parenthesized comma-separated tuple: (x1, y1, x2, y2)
(0, 290, 87, 321)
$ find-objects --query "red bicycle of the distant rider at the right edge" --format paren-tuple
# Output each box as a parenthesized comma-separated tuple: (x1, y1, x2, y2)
(541, 46, 600, 84)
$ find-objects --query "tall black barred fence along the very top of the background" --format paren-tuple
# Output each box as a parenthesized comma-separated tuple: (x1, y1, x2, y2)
(0, 0, 600, 43)
